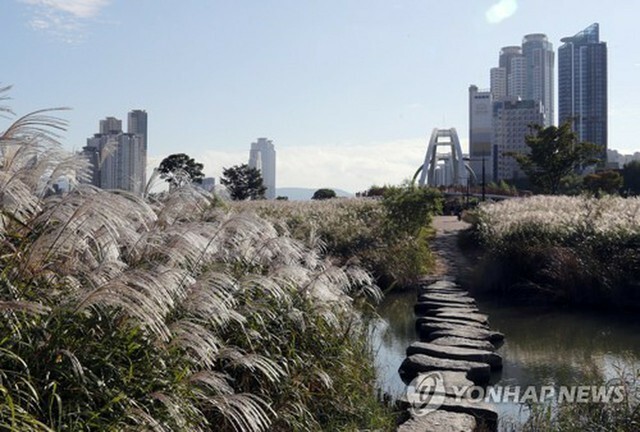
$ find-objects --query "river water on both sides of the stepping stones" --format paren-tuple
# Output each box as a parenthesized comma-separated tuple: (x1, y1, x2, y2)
(372, 291, 640, 430)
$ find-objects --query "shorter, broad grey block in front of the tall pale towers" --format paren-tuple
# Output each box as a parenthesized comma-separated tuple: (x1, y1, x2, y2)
(491, 97, 544, 180)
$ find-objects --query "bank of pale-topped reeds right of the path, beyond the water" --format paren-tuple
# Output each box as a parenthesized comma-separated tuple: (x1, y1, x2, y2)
(469, 196, 640, 308)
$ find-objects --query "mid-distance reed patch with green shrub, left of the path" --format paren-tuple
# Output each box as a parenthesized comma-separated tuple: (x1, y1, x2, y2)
(231, 186, 442, 289)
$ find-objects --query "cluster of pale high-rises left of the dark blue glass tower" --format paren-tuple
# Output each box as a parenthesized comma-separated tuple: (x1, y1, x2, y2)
(469, 28, 556, 182)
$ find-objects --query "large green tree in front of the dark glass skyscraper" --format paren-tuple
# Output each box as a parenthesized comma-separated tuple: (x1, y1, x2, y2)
(505, 122, 600, 195)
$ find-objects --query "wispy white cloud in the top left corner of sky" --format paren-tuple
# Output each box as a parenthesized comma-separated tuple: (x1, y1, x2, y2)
(19, 0, 111, 43)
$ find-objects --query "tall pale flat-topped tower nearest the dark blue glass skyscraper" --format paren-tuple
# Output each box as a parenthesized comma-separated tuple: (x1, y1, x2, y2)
(522, 33, 555, 126)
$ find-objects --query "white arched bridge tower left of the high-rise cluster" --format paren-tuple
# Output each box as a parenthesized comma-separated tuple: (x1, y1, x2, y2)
(419, 128, 467, 186)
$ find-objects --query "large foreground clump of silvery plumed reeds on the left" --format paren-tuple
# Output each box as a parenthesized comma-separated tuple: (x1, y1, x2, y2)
(0, 93, 404, 431)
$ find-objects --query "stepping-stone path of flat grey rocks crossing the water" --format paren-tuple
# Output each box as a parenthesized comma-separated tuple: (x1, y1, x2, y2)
(398, 280, 504, 432)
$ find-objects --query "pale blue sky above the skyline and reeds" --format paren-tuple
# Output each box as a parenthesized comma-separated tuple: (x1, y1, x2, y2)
(0, 0, 640, 192)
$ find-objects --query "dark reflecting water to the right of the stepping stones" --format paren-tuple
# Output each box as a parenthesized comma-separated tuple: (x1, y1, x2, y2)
(477, 300, 640, 424)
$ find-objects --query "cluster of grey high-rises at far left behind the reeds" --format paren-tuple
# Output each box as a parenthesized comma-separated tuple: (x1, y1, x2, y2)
(82, 111, 147, 194)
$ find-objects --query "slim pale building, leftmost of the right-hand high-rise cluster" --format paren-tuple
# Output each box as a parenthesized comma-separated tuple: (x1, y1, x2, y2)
(469, 87, 496, 182)
